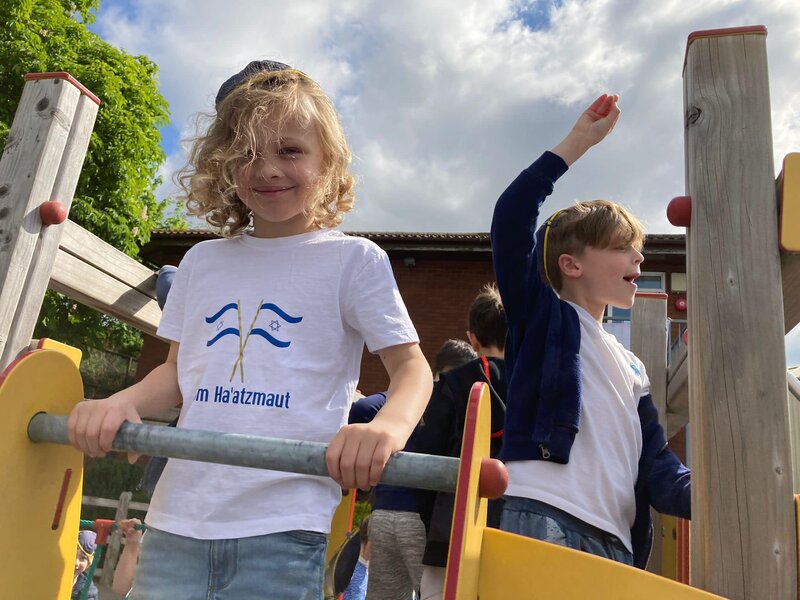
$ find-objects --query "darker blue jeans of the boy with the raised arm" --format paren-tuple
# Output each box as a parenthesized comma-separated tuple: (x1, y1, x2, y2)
(500, 496, 633, 566)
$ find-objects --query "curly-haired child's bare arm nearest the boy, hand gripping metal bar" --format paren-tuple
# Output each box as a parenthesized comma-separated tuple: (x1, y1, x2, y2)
(326, 344, 433, 489)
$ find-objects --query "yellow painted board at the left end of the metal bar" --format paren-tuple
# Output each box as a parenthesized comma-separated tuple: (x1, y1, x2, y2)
(0, 350, 83, 600)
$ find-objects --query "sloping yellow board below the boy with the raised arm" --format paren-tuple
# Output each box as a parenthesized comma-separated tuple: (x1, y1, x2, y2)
(477, 528, 720, 600)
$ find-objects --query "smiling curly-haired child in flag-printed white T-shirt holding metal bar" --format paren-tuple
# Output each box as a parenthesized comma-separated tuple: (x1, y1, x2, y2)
(68, 61, 432, 600)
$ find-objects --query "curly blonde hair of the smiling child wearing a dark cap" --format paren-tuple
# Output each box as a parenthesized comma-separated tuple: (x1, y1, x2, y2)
(183, 69, 355, 236)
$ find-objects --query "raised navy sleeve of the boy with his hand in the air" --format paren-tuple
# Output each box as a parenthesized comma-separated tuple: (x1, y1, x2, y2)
(491, 152, 567, 323)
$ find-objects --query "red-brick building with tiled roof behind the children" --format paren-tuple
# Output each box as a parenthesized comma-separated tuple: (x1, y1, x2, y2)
(138, 230, 686, 394)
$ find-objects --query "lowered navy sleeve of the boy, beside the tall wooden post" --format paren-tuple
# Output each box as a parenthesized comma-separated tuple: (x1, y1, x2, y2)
(639, 394, 692, 519)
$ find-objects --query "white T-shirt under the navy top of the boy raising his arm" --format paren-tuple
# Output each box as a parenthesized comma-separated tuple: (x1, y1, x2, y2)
(506, 302, 650, 551)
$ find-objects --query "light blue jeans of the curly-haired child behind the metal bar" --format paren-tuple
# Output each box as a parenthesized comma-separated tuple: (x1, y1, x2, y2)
(128, 527, 328, 600)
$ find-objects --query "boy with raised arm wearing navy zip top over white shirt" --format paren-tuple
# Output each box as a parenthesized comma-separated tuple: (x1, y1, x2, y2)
(491, 94, 691, 568)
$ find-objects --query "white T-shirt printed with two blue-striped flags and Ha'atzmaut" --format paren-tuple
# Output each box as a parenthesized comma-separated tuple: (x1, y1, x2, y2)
(147, 230, 418, 539)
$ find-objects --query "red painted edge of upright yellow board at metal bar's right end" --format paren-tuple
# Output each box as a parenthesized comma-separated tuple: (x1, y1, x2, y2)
(443, 382, 484, 600)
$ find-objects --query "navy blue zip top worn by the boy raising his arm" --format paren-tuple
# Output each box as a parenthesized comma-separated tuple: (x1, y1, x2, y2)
(491, 152, 691, 568)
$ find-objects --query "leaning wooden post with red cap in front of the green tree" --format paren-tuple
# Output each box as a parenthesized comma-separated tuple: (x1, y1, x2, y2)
(0, 73, 99, 368)
